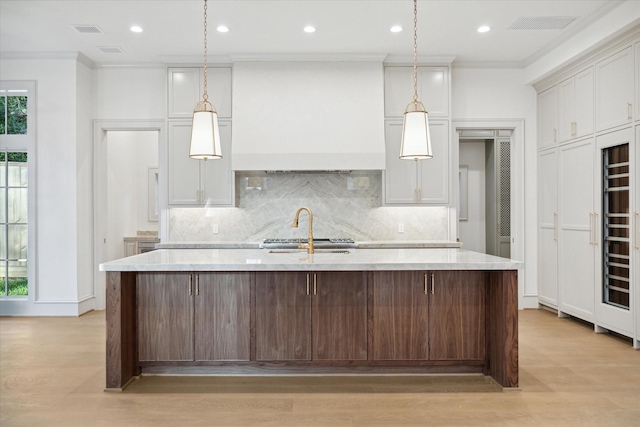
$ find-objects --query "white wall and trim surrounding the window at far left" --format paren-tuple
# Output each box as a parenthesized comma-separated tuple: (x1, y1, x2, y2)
(0, 56, 83, 315)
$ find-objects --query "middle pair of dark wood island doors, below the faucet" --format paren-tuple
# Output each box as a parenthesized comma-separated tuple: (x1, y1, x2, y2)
(256, 271, 367, 361)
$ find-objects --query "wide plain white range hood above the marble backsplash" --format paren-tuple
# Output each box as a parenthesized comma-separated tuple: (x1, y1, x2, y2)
(232, 61, 385, 171)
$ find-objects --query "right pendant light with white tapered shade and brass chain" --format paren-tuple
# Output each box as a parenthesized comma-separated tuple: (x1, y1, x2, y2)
(400, 0, 433, 161)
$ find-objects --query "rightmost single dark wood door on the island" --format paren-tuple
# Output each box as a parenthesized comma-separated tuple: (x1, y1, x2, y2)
(429, 271, 485, 360)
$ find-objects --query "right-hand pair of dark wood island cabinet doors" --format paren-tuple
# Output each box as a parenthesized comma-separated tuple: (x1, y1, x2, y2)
(373, 271, 485, 360)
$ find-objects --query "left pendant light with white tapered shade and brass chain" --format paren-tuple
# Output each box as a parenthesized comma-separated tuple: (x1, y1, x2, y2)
(189, 0, 222, 160)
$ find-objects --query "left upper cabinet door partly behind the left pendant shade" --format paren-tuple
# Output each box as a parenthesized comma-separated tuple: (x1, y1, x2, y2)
(167, 120, 200, 205)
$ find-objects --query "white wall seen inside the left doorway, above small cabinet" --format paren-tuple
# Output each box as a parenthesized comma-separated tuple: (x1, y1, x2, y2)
(107, 131, 158, 260)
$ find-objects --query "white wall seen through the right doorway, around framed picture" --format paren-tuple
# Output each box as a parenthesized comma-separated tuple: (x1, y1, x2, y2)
(458, 141, 487, 253)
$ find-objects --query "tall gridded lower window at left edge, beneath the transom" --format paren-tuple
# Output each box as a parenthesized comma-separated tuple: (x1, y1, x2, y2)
(0, 150, 29, 296)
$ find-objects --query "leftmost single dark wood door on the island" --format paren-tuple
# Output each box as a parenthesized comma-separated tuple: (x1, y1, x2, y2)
(137, 273, 193, 361)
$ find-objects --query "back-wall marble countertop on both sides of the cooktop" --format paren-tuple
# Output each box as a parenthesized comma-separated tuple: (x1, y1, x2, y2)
(156, 240, 462, 249)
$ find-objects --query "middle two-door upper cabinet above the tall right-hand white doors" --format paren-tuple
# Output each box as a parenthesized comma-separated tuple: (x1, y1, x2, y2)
(558, 68, 593, 142)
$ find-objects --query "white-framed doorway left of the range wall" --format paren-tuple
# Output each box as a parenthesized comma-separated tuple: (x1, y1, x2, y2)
(93, 120, 166, 310)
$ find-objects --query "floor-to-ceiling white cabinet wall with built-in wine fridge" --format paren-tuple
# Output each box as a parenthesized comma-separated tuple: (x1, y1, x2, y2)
(535, 32, 640, 348)
